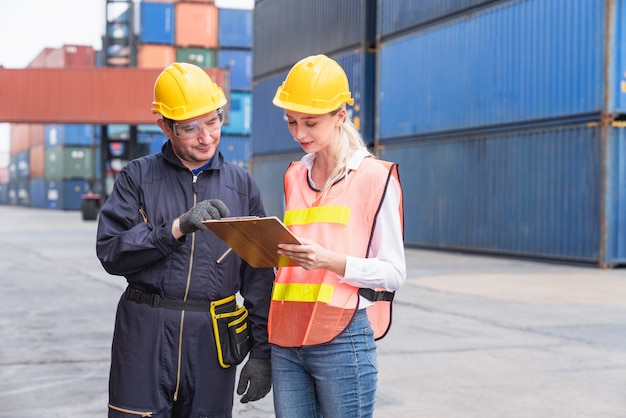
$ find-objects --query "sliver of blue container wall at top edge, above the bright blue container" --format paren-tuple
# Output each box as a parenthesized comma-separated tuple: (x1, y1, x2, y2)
(376, 0, 503, 38)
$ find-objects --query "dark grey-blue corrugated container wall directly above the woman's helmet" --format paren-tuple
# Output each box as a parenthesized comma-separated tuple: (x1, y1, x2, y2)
(254, 0, 376, 77)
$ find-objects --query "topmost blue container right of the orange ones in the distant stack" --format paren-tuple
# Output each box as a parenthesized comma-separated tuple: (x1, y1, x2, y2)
(217, 8, 253, 48)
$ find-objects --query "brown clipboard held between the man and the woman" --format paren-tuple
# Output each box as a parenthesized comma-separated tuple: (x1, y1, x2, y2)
(202, 216, 300, 267)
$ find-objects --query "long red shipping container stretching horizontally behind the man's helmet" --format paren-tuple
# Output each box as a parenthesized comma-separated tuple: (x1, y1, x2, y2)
(0, 66, 230, 124)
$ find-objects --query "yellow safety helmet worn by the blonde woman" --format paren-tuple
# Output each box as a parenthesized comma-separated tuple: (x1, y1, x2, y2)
(272, 54, 354, 115)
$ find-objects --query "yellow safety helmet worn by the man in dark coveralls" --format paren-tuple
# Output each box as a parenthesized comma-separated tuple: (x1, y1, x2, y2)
(152, 62, 226, 120)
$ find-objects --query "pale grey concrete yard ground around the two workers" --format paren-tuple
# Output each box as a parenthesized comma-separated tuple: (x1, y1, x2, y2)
(0, 206, 626, 418)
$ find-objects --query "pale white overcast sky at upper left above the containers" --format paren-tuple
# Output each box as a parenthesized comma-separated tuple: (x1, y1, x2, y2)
(0, 0, 254, 151)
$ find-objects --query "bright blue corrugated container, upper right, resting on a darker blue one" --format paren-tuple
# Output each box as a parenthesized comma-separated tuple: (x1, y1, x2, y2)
(378, 0, 626, 140)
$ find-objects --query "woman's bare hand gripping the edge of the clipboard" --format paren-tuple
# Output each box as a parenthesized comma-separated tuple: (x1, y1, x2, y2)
(278, 238, 346, 276)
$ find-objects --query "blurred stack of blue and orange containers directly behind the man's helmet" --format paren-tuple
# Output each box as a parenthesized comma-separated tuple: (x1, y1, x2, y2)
(137, 1, 253, 166)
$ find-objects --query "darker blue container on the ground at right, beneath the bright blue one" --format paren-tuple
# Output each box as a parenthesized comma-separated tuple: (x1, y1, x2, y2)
(380, 123, 626, 266)
